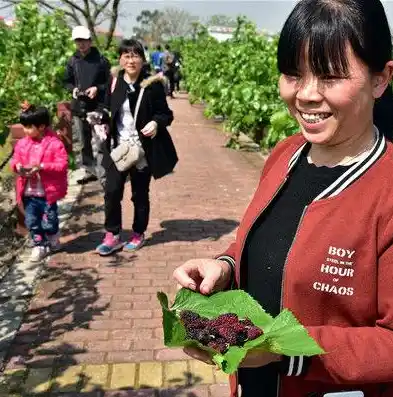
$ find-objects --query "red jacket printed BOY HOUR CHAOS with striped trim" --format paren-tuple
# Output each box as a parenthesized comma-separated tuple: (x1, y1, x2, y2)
(222, 131, 393, 397)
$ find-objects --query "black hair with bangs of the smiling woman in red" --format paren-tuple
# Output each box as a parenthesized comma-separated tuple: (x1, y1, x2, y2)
(277, 0, 392, 77)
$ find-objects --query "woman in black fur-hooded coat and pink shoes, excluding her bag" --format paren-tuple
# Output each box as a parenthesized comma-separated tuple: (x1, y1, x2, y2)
(97, 40, 178, 256)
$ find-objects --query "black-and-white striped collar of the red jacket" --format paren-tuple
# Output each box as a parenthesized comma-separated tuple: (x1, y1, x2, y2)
(287, 126, 387, 201)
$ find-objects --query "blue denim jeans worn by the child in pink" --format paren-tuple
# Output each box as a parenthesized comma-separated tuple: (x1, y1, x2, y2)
(23, 196, 59, 245)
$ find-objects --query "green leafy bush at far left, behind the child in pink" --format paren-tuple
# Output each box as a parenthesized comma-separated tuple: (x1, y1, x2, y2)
(0, 0, 73, 144)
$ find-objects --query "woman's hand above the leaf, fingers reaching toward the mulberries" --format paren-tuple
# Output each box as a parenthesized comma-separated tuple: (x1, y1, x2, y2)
(173, 259, 232, 295)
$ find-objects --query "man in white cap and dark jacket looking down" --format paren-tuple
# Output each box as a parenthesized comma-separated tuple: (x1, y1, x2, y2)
(64, 26, 110, 184)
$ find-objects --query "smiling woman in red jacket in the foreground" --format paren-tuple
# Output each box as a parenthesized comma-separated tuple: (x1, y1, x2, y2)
(174, 0, 393, 397)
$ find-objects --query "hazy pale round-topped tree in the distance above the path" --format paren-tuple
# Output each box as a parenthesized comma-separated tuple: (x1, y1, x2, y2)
(161, 7, 198, 39)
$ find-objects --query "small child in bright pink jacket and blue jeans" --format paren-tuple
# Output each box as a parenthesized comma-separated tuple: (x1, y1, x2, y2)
(11, 103, 68, 262)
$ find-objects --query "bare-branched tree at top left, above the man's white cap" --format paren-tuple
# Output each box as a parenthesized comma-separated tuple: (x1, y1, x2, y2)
(3, 0, 121, 49)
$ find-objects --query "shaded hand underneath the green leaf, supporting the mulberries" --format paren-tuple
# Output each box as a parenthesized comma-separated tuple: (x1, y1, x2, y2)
(183, 347, 281, 368)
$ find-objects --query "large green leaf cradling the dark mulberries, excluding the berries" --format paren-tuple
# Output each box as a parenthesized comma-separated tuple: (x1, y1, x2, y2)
(157, 288, 325, 374)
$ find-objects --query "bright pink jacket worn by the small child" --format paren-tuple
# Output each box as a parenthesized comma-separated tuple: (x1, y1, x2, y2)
(11, 129, 68, 204)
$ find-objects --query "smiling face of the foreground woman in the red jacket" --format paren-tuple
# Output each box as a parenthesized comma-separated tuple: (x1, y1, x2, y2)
(279, 46, 384, 145)
